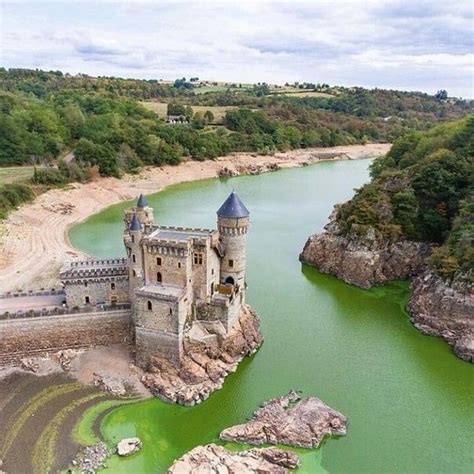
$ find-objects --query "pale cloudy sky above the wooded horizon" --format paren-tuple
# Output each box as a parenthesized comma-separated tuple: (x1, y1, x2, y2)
(0, 0, 474, 98)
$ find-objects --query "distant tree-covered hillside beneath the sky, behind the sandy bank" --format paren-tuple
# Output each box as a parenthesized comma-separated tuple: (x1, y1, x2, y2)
(0, 69, 472, 219)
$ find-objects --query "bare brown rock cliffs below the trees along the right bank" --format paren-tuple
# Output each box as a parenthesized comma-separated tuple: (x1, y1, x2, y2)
(300, 212, 474, 362)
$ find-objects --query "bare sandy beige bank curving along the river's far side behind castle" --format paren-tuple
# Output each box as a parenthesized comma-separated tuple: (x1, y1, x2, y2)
(0, 143, 391, 294)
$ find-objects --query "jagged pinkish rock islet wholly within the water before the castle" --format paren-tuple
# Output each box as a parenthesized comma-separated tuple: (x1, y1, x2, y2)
(220, 391, 347, 448)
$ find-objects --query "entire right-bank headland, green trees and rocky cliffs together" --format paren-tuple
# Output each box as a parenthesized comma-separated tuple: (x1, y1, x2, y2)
(300, 117, 474, 362)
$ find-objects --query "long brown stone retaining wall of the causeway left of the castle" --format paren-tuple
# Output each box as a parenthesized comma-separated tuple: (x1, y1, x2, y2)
(0, 309, 131, 365)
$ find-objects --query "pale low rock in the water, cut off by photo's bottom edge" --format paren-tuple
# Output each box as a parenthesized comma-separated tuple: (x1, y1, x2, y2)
(168, 444, 299, 474)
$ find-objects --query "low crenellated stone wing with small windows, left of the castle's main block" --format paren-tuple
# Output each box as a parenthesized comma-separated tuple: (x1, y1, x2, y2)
(64, 277, 129, 308)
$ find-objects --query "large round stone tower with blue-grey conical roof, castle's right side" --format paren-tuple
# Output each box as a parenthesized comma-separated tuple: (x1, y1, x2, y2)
(217, 191, 250, 288)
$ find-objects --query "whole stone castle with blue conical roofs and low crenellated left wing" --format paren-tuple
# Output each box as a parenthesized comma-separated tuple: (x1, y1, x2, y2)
(60, 192, 249, 368)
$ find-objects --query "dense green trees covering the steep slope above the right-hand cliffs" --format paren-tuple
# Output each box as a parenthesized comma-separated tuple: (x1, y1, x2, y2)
(337, 116, 474, 281)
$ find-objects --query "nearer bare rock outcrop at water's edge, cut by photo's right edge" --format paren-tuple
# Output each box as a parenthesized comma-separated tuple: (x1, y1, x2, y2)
(408, 271, 474, 362)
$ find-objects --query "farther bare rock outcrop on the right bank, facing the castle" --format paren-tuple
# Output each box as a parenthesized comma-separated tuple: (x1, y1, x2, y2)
(300, 211, 430, 288)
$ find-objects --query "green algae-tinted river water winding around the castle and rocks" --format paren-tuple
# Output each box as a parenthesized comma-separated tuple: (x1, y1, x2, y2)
(70, 160, 474, 473)
